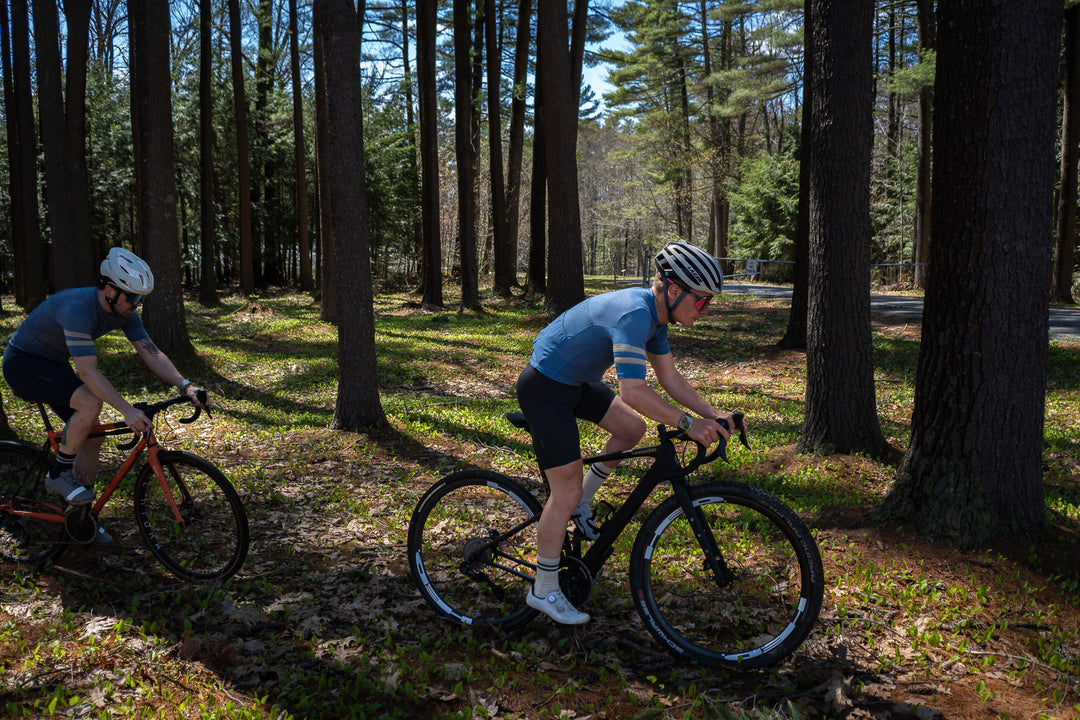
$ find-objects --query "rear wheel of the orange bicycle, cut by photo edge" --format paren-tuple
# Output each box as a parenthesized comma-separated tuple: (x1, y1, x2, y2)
(0, 440, 68, 565)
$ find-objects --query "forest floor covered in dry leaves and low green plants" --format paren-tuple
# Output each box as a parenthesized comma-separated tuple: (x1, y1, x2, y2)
(0, 286, 1080, 720)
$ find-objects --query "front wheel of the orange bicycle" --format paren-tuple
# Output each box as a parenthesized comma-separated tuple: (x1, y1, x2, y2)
(135, 451, 248, 582)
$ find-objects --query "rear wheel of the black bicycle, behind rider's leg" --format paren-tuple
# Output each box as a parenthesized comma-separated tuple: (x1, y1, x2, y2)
(408, 470, 541, 629)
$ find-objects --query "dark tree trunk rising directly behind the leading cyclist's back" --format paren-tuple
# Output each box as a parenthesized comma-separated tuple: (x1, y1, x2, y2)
(537, 0, 589, 315)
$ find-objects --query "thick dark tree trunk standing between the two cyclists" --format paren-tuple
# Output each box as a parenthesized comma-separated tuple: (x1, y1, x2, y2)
(314, 0, 387, 431)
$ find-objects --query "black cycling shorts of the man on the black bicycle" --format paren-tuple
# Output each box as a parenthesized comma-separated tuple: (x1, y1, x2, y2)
(517, 365, 615, 470)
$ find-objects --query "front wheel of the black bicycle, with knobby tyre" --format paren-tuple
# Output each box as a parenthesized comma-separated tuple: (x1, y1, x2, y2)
(630, 483, 825, 669)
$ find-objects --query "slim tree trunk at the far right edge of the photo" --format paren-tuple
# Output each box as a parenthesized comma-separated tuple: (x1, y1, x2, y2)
(1050, 4, 1080, 304)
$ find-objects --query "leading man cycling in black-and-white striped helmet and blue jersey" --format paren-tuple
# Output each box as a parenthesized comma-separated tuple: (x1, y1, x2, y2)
(517, 243, 731, 625)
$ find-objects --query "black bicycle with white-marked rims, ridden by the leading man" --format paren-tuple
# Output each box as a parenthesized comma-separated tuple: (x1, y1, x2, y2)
(408, 412, 825, 669)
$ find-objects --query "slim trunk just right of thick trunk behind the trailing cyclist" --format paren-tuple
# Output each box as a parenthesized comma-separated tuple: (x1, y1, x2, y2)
(199, 0, 217, 304)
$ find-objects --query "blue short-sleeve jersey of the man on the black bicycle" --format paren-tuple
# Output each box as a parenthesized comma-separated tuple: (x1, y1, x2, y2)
(529, 287, 671, 385)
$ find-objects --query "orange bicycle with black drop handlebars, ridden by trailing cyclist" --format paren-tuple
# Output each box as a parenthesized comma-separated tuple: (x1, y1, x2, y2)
(0, 391, 248, 582)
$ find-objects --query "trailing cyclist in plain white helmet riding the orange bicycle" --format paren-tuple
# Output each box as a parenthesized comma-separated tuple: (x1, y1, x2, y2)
(3, 247, 202, 546)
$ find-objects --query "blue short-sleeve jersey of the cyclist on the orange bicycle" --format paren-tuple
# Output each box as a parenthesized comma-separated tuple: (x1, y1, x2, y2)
(10, 287, 148, 363)
